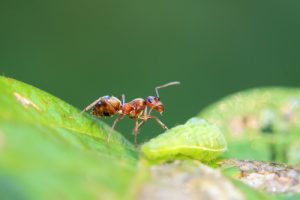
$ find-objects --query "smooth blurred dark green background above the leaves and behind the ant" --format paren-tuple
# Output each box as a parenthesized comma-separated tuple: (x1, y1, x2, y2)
(0, 0, 300, 141)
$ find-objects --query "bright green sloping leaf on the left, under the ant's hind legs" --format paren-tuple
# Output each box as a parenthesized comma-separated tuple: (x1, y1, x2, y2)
(0, 77, 138, 199)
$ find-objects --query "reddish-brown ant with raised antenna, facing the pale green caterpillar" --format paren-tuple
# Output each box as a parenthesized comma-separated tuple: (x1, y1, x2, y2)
(82, 81, 180, 144)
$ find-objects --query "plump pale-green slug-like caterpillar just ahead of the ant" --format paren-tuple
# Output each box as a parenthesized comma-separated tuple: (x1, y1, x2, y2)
(142, 118, 227, 162)
